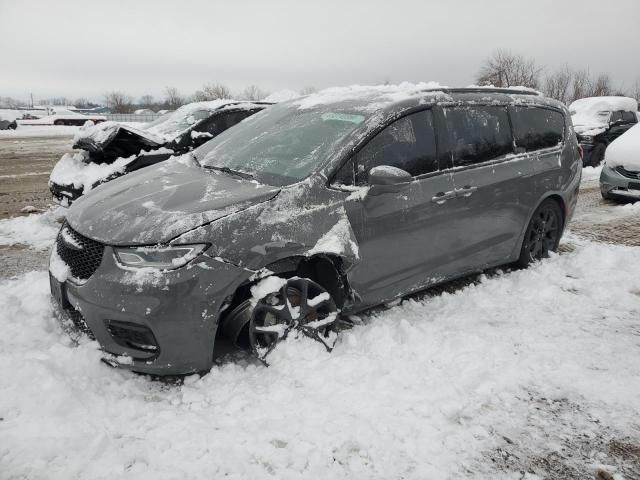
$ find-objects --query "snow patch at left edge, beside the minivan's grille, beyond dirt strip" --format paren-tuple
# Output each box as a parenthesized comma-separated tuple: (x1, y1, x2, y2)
(0, 207, 65, 250)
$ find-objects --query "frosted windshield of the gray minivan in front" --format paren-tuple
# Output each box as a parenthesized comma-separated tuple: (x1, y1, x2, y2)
(194, 104, 365, 186)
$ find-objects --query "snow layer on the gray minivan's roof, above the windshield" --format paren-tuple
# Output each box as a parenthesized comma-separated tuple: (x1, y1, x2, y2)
(294, 82, 446, 110)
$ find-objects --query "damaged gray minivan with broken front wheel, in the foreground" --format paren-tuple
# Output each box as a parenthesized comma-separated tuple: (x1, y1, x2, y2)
(50, 86, 582, 375)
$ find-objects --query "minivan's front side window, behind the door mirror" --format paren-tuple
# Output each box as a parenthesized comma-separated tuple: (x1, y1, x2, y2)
(336, 110, 438, 185)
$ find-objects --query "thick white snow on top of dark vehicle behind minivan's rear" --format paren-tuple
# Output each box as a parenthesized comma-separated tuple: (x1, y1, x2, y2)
(569, 97, 638, 135)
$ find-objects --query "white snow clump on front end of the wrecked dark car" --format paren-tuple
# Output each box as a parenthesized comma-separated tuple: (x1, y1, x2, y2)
(49, 150, 137, 193)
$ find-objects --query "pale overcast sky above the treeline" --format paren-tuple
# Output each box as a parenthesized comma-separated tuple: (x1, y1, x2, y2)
(0, 0, 640, 101)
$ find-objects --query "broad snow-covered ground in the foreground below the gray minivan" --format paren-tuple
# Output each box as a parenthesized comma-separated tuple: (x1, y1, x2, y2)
(0, 240, 640, 480)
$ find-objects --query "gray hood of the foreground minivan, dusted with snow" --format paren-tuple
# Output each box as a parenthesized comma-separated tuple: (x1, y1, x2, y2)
(67, 160, 279, 245)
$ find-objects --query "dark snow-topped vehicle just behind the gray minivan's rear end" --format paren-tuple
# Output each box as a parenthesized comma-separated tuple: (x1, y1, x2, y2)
(569, 97, 638, 167)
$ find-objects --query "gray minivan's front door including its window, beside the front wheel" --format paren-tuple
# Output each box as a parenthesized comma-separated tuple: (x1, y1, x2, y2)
(343, 110, 460, 304)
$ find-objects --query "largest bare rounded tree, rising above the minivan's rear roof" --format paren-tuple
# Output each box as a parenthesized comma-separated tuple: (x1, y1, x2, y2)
(476, 50, 542, 88)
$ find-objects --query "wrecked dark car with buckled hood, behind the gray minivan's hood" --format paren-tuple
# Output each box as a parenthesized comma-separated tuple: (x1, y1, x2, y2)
(49, 100, 270, 206)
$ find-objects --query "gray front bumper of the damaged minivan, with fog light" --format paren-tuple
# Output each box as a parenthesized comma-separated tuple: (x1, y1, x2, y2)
(52, 246, 253, 375)
